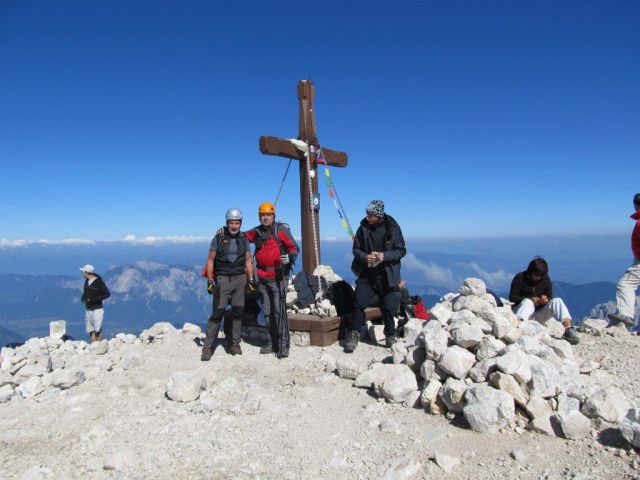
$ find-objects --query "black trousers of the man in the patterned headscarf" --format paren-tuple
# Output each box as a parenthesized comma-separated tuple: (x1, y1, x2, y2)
(351, 277, 402, 337)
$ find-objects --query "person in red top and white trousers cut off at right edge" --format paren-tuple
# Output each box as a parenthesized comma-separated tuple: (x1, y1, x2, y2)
(609, 193, 640, 327)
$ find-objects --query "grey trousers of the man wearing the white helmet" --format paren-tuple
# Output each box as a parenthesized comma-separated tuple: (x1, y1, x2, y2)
(204, 273, 247, 348)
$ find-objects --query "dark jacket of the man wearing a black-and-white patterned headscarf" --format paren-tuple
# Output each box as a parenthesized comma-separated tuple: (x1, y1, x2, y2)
(351, 215, 407, 288)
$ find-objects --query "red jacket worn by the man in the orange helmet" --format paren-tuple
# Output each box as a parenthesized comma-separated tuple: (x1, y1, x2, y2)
(245, 224, 298, 279)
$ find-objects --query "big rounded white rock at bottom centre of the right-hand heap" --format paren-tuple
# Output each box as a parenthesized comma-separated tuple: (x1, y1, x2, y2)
(463, 384, 515, 433)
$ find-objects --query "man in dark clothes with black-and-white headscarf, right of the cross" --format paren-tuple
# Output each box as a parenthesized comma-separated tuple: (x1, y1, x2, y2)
(344, 200, 407, 353)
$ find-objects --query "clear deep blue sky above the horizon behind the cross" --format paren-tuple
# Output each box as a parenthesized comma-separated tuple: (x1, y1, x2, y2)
(0, 0, 640, 243)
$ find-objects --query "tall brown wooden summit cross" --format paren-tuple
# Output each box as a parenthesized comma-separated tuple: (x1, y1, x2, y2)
(260, 80, 348, 273)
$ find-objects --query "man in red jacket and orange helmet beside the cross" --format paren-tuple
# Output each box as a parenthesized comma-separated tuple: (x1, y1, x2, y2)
(245, 202, 299, 358)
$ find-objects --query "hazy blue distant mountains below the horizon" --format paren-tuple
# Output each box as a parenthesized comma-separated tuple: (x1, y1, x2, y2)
(0, 261, 615, 345)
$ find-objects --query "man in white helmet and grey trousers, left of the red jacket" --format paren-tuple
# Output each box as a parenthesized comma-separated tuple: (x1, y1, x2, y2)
(200, 208, 255, 361)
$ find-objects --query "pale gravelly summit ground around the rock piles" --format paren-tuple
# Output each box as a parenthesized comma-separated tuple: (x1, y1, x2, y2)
(0, 324, 640, 480)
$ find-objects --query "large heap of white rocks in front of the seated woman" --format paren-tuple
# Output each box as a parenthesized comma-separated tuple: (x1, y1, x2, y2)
(355, 278, 636, 439)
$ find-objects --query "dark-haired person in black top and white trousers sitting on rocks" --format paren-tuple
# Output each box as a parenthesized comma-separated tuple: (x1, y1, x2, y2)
(509, 257, 580, 345)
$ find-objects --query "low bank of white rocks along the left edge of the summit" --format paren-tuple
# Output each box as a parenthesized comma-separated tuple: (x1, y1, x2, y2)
(0, 322, 200, 403)
